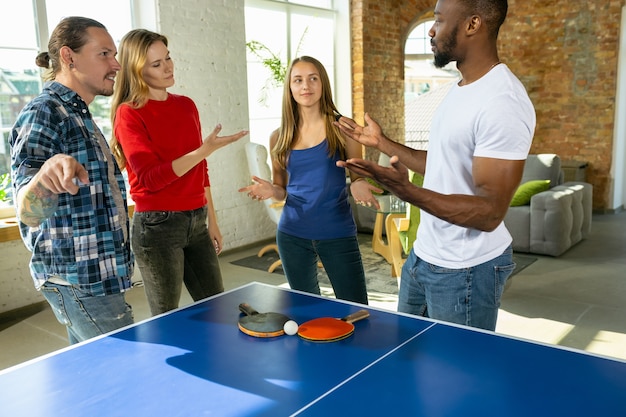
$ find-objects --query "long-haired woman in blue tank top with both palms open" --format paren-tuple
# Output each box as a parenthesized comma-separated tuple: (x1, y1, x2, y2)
(240, 56, 380, 304)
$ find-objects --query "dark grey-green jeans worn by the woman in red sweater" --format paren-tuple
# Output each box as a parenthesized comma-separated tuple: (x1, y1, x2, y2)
(131, 206, 224, 315)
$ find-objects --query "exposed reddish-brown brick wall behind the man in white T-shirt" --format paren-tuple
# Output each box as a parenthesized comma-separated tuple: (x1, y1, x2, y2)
(351, 0, 626, 210)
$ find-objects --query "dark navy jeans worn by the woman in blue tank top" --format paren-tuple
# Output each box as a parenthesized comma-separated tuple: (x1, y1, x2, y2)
(276, 231, 367, 304)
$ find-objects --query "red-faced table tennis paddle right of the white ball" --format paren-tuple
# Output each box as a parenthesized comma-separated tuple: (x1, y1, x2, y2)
(298, 310, 370, 342)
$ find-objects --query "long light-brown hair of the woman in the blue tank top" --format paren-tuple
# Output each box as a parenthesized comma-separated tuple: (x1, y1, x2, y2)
(272, 56, 346, 169)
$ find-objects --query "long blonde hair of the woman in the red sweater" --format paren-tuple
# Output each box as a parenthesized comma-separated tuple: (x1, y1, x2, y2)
(110, 29, 167, 170)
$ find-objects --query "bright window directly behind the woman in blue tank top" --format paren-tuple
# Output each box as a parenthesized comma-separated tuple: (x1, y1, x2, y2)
(245, 0, 352, 154)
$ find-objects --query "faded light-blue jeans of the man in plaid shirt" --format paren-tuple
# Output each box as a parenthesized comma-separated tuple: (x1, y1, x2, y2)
(41, 281, 134, 344)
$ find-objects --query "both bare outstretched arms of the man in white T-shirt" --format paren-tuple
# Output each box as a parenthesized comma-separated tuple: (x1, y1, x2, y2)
(336, 114, 525, 232)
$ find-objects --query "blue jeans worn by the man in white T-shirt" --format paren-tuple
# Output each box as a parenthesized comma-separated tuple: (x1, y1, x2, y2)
(398, 246, 515, 330)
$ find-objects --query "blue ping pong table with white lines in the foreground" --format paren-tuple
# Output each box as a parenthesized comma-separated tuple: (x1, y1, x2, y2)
(0, 283, 626, 417)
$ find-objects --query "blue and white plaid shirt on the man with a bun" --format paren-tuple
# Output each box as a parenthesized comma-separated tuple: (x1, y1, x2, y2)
(9, 81, 134, 296)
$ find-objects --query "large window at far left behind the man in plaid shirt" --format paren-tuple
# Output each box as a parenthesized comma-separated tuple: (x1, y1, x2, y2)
(0, 0, 141, 217)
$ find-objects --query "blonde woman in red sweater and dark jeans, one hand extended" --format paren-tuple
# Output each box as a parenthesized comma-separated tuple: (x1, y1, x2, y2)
(111, 29, 248, 315)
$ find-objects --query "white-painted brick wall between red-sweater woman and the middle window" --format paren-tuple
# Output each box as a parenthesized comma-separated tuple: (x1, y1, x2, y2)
(157, 0, 276, 250)
